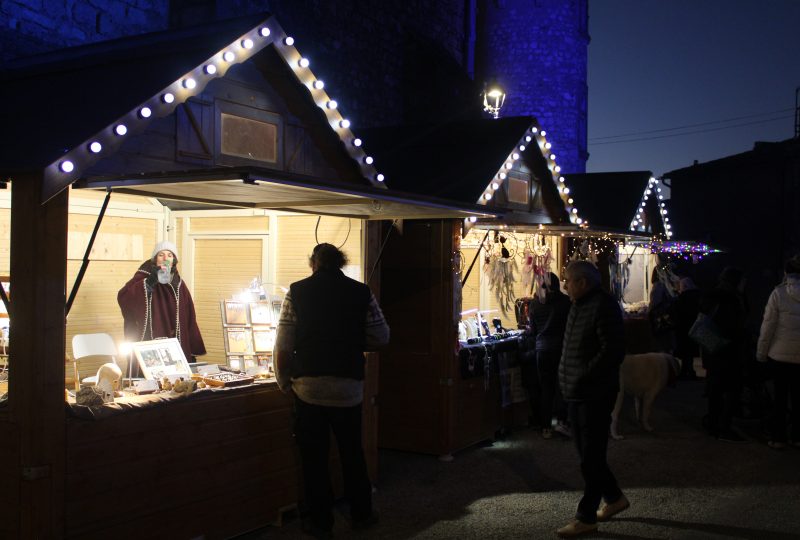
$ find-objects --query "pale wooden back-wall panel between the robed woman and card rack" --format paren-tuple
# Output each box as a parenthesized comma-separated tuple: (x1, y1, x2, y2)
(192, 237, 266, 364)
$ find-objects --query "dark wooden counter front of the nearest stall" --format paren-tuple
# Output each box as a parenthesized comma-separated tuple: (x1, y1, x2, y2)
(65, 386, 299, 539)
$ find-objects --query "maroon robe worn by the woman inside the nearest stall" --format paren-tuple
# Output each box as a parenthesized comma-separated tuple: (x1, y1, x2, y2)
(117, 261, 206, 362)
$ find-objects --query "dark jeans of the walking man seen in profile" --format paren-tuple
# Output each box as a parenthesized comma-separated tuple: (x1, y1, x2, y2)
(568, 394, 622, 523)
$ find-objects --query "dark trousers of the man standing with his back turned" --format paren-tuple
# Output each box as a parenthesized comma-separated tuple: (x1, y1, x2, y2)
(294, 397, 372, 530)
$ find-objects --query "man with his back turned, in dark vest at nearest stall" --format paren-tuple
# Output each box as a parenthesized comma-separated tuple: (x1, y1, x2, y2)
(274, 244, 389, 538)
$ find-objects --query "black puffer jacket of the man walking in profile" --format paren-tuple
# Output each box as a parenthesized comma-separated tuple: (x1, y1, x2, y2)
(558, 287, 625, 400)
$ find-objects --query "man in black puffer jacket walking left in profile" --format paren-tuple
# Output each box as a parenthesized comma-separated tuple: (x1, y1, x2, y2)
(556, 261, 630, 538)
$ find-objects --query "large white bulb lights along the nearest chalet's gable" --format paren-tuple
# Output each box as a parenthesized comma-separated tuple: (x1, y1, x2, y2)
(45, 17, 386, 196)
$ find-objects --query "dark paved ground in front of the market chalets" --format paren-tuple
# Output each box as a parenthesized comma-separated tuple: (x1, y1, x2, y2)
(241, 381, 800, 540)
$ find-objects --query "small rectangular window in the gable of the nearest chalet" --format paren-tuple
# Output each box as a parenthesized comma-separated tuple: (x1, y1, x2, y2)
(220, 113, 278, 163)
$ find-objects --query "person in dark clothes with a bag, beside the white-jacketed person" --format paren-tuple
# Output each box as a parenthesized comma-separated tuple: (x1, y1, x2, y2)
(698, 266, 747, 442)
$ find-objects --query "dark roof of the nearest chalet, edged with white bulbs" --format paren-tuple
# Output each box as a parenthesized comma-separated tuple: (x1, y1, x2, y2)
(0, 14, 385, 205)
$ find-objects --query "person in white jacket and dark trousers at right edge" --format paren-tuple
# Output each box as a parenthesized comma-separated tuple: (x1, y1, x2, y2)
(756, 254, 800, 449)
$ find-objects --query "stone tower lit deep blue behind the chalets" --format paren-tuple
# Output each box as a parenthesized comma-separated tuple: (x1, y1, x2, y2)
(476, 0, 589, 173)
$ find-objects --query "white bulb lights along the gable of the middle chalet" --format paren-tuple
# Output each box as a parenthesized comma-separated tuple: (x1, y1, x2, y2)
(467, 123, 589, 227)
